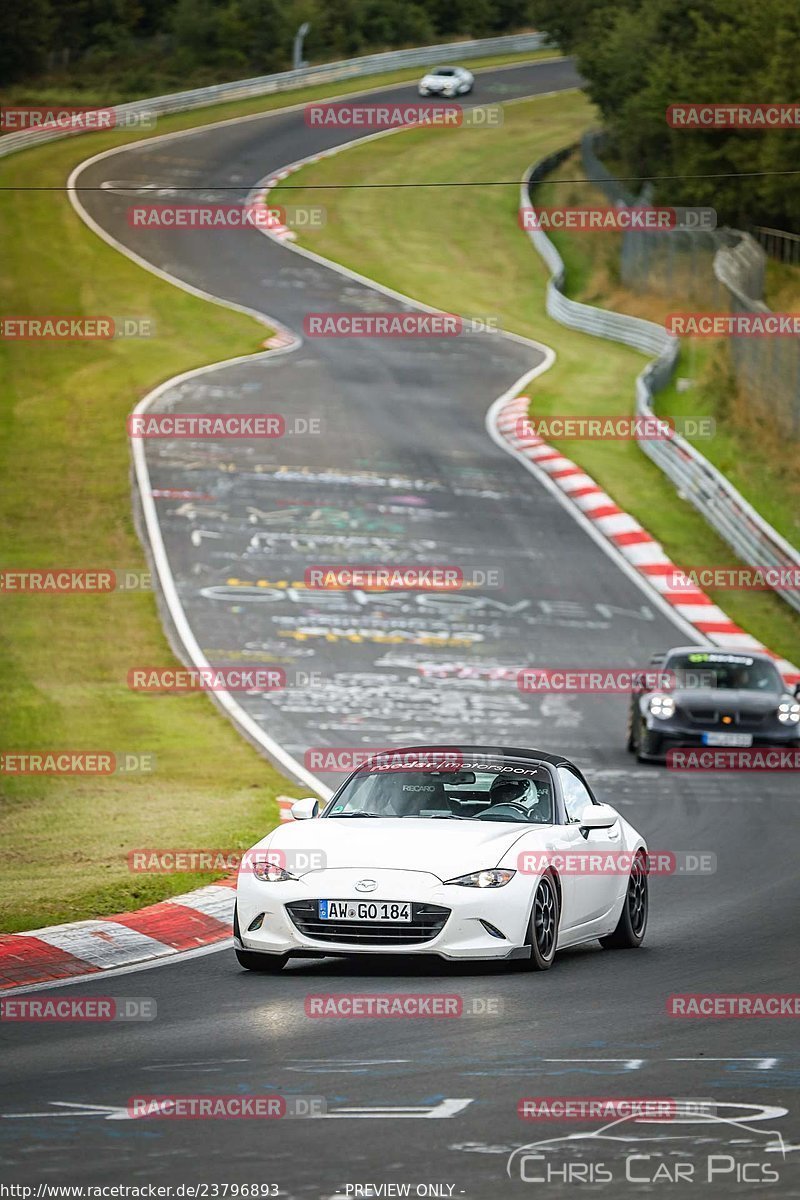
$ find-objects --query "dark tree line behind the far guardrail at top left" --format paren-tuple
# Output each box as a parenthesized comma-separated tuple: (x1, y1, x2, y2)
(0, 0, 530, 95)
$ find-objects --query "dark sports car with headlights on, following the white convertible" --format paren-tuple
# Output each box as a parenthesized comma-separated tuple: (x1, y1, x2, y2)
(627, 646, 800, 762)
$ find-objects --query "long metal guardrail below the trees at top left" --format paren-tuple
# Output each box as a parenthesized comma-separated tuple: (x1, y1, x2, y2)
(0, 34, 553, 156)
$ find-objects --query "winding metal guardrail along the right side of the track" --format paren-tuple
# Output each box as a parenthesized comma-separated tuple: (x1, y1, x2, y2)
(521, 146, 800, 612)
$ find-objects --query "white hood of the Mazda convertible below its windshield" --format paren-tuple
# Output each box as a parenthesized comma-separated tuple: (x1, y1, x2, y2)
(253, 817, 555, 880)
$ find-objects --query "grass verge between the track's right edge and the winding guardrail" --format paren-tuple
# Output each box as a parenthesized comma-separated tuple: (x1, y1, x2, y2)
(280, 92, 800, 659)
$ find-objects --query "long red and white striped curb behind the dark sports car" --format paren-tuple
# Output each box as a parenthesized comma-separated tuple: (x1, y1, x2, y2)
(494, 396, 800, 684)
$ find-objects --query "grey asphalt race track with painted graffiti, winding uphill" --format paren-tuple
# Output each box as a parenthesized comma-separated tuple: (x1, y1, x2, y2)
(0, 64, 800, 1198)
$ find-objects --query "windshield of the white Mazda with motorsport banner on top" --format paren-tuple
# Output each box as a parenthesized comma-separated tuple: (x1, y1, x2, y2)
(323, 761, 553, 824)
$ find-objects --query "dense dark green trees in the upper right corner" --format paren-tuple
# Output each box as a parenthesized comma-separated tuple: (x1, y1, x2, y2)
(531, 0, 800, 230)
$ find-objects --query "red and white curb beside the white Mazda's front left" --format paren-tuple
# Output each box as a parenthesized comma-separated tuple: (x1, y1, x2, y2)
(0, 796, 295, 991)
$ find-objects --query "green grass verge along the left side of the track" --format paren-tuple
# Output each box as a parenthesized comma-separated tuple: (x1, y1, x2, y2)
(0, 55, 563, 932)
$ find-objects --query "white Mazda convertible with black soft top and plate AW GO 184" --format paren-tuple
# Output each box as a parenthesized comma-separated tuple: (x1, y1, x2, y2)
(234, 746, 648, 972)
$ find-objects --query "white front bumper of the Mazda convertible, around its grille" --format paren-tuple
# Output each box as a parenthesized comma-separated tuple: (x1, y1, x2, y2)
(236, 869, 535, 960)
